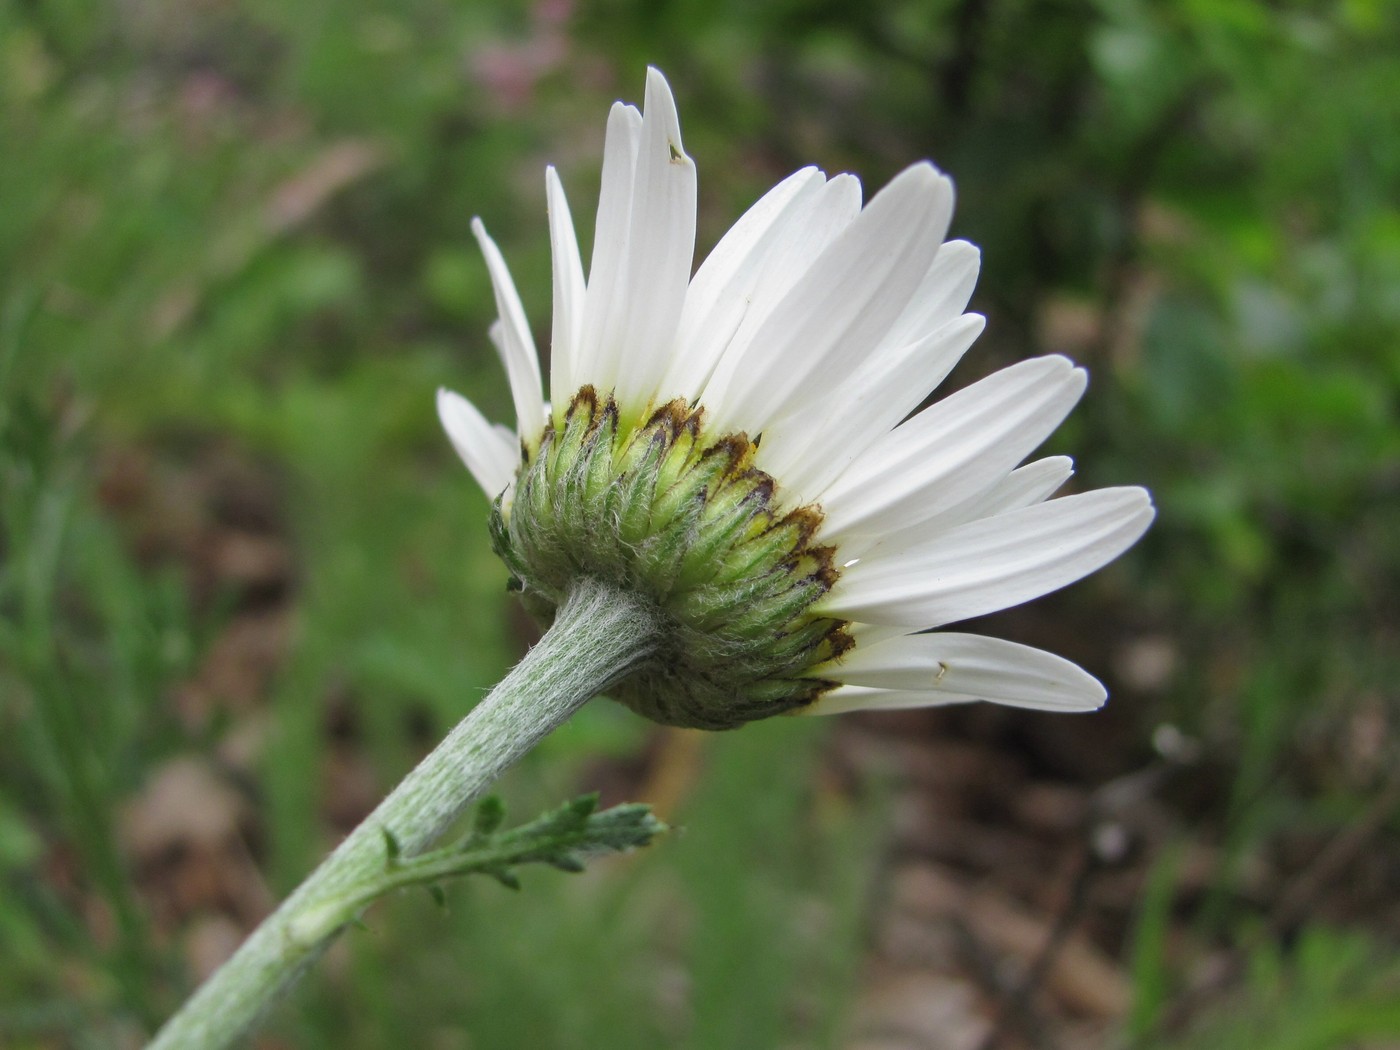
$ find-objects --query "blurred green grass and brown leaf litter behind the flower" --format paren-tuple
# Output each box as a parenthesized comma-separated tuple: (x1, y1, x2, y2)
(0, 0, 1400, 1050)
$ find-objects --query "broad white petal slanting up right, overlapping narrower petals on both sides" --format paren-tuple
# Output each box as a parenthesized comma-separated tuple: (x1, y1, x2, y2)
(706, 164, 952, 434)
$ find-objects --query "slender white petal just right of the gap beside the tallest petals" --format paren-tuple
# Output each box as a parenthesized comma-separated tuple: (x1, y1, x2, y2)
(662, 168, 823, 399)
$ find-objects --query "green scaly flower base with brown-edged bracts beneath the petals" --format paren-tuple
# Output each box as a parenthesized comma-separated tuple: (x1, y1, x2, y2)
(491, 386, 853, 729)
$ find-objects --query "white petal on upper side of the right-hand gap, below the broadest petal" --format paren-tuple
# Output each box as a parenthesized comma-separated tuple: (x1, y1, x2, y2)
(757, 314, 986, 507)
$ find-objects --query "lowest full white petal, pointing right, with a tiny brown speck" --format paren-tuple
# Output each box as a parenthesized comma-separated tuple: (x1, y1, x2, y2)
(813, 631, 1107, 711)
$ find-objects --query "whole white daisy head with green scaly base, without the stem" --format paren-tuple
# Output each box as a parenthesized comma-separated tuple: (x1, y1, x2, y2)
(438, 70, 1154, 728)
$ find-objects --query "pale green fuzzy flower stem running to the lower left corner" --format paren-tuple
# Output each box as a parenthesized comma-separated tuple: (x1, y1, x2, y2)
(148, 577, 658, 1050)
